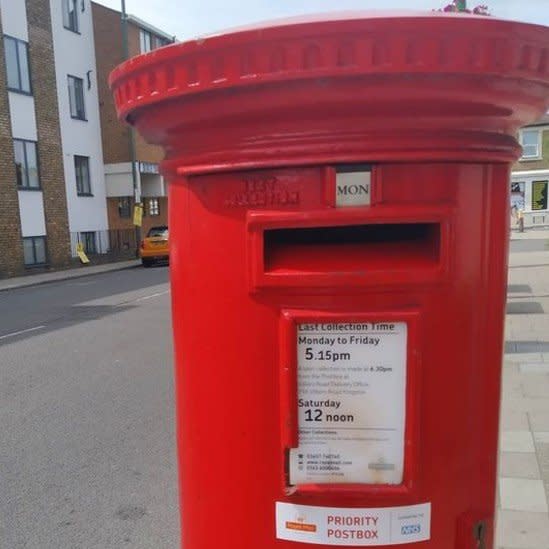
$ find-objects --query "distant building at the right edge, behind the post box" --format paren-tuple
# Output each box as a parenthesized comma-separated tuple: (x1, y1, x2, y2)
(511, 113, 549, 227)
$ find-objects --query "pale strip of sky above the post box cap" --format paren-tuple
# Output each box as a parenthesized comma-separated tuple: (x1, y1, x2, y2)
(94, 0, 549, 40)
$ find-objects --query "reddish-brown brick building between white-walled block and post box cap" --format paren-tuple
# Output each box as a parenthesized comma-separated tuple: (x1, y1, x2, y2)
(92, 3, 173, 240)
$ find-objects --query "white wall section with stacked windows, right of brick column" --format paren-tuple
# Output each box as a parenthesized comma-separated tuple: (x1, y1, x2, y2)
(49, 0, 109, 256)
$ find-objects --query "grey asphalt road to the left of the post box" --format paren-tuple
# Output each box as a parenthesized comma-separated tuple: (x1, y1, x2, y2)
(0, 267, 179, 549)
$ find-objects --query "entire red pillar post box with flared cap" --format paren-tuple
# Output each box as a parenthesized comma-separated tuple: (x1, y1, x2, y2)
(111, 14, 549, 549)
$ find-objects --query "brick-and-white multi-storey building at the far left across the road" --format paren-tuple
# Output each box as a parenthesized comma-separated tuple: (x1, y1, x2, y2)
(0, 0, 107, 277)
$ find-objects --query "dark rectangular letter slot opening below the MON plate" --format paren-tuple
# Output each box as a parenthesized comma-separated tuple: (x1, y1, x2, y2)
(264, 223, 440, 273)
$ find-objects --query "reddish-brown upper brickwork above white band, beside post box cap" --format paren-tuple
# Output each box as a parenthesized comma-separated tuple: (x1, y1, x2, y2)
(92, 3, 163, 164)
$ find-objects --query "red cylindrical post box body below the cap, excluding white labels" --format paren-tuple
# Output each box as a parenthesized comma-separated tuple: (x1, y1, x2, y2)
(170, 159, 509, 549)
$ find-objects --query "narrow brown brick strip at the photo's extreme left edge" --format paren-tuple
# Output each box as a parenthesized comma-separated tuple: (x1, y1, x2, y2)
(0, 15, 23, 278)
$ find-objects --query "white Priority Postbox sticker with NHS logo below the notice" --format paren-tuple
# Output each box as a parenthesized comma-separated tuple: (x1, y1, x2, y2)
(276, 502, 431, 547)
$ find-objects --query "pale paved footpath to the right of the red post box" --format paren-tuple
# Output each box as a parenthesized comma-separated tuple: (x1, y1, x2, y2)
(496, 229, 549, 549)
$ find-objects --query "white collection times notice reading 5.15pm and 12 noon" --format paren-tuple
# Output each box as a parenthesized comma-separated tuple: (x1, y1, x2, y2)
(290, 320, 407, 485)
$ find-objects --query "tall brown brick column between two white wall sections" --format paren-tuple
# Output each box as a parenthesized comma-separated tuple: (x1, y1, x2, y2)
(26, 0, 71, 267)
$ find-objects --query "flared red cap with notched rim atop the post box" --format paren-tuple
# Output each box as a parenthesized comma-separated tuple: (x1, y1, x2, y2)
(110, 12, 549, 173)
